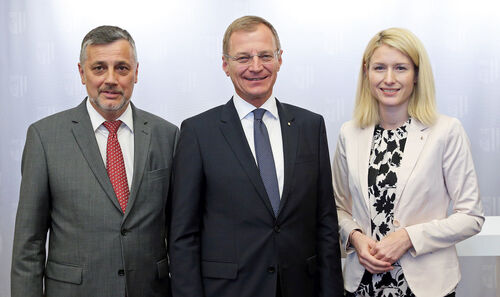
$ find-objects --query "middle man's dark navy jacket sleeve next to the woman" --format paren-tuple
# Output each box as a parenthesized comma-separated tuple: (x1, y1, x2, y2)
(317, 118, 344, 297)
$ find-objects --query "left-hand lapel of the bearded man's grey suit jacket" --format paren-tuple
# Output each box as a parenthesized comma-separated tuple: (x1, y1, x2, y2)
(72, 100, 121, 212)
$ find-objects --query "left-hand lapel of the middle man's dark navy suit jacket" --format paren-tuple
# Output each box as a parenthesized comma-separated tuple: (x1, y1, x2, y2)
(220, 99, 274, 216)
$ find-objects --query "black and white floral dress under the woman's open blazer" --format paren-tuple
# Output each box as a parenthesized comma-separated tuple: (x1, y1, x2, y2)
(354, 119, 415, 297)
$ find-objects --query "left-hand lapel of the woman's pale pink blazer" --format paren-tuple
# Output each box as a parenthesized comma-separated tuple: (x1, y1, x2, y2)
(356, 125, 374, 207)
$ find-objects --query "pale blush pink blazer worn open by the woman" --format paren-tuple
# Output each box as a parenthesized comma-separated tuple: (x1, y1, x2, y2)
(333, 115, 484, 297)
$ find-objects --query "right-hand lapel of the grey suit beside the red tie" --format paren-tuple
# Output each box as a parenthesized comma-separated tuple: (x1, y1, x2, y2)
(124, 103, 151, 219)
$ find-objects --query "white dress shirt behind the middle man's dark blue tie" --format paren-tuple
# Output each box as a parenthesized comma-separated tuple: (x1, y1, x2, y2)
(233, 94, 285, 198)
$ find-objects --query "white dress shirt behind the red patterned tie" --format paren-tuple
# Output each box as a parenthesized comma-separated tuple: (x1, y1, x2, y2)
(87, 99, 134, 189)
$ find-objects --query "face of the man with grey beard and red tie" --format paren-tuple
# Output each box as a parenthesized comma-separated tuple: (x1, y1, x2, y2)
(78, 39, 139, 120)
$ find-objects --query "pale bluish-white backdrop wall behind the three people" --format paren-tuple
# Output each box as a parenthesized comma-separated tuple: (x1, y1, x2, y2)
(0, 0, 500, 297)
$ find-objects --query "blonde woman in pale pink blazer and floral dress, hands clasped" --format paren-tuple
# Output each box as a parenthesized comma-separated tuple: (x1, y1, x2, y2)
(333, 28, 484, 297)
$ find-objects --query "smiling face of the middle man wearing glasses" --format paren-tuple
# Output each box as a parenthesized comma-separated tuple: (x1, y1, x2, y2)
(222, 24, 282, 107)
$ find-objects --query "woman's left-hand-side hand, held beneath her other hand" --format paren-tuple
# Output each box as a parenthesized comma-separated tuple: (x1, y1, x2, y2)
(349, 230, 394, 273)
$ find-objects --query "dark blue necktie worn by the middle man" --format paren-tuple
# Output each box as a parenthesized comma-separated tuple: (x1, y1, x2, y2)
(253, 108, 280, 216)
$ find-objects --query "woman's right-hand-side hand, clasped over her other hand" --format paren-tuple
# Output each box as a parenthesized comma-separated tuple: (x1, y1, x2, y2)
(370, 228, 413, 264)
